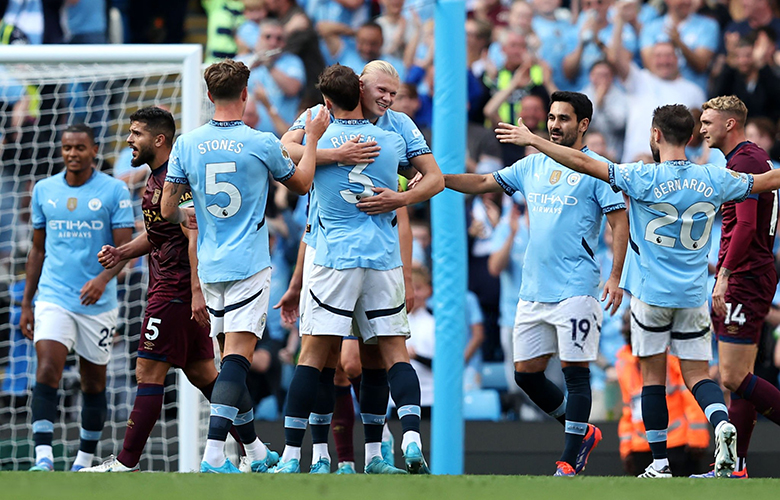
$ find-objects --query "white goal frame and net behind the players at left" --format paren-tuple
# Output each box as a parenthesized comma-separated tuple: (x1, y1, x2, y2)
(0, 44, 205, 472)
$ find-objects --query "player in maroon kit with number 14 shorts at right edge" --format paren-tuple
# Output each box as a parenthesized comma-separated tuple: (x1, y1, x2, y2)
(696, 96, 780, 478)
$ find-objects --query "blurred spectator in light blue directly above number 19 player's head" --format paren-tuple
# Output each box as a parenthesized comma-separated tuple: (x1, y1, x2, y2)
(563, 0, 639, 90)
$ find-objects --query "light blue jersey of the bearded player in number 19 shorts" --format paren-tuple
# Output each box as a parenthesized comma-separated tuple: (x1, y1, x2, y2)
(493, 148, 626, 303)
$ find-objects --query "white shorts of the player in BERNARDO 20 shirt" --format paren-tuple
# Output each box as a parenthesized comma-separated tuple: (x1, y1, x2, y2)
(631, 297, 712, 361)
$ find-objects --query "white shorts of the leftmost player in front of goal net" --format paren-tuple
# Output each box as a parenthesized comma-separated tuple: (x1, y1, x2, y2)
(33, 300, 119, 365)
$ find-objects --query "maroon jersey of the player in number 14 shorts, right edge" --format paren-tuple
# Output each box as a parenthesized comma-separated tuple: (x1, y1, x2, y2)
(718, 142, 778, 273)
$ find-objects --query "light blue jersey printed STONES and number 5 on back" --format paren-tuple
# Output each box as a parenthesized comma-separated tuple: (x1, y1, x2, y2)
(165, 120, 295, 283)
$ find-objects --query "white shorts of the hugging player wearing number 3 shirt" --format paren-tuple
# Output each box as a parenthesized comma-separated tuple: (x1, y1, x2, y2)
(301, 264, 410, 343)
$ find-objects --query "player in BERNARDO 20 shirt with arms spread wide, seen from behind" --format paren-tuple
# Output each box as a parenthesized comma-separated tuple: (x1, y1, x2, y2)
(496, 104, 780, 478)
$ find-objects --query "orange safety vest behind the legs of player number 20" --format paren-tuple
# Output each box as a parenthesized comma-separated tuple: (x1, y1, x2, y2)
(615, 345, 710, 458)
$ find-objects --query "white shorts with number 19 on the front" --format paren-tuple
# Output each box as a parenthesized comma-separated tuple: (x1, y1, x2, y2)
(512, 295, 602, 363)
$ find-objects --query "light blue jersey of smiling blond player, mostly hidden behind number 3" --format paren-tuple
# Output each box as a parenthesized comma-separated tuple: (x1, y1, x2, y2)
(290, 104, 431, 247)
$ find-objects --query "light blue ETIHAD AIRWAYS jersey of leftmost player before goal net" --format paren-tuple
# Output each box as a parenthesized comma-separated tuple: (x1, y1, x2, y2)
(31, 171, 135, 315)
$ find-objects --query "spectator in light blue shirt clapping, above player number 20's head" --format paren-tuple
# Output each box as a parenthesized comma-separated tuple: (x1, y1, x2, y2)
(639, 0, 720, 91)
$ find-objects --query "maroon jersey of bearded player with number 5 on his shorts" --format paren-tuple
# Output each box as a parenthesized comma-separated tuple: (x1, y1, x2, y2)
(141, 162, 192, 302)
